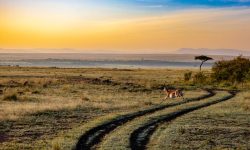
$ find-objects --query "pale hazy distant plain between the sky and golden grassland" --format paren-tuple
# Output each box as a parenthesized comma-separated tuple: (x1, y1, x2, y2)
(0, 53, 249, 69)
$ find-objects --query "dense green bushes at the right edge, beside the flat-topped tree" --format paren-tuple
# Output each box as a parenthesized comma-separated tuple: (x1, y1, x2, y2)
(183, 56, 250, 90)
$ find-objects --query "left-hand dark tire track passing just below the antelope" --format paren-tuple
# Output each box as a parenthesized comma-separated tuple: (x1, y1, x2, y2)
(75, 90, 215, 150)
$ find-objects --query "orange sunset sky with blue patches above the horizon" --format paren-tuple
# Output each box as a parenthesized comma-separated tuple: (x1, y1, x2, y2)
(0, 0, 250, 53)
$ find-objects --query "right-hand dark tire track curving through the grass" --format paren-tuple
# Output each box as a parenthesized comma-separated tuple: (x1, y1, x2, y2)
(129, 91, 237, 150)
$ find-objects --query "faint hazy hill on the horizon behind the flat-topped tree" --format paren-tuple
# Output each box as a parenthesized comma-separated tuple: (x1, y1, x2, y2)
(176, 48, 250, 56)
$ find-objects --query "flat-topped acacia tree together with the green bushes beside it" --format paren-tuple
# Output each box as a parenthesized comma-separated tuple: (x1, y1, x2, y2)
(184, 55, 250, 88)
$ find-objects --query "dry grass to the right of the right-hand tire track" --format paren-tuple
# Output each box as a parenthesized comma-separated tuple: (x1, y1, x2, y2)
(149, 92, 250, 150)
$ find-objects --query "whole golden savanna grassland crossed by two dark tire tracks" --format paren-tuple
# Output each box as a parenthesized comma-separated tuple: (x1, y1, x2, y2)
(0, 67, 250, 149)
